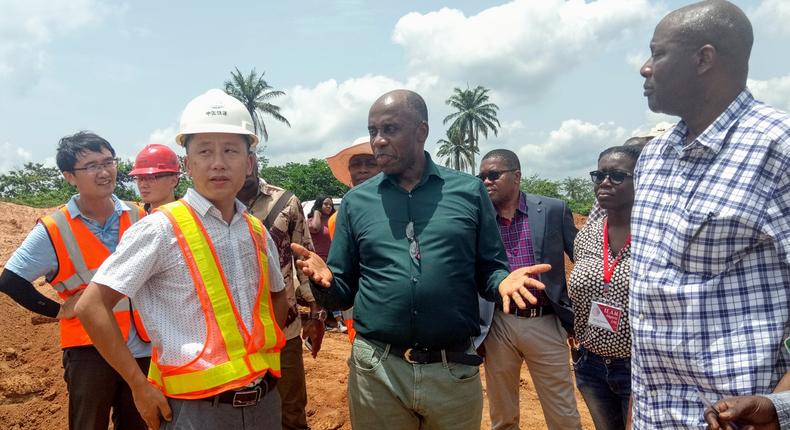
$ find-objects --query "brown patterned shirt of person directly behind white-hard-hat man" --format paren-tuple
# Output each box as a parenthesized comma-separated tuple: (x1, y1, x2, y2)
(247, 179, 315, 339)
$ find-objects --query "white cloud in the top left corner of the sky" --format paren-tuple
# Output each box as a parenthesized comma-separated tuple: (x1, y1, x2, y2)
(0, 0, 106, 92)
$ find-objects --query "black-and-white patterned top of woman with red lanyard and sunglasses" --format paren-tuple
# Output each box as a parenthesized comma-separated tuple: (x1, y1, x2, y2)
(568, 218, 631, 358)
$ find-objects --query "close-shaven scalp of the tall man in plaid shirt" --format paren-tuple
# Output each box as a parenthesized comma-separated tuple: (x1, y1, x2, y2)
(659, 0, 754, 83)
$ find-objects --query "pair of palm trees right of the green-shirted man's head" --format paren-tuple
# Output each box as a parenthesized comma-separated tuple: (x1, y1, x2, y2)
(436, 85, 500, 174)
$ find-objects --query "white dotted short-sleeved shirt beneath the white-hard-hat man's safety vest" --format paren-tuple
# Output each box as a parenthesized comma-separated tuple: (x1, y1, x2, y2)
(93, 189, 284, 365)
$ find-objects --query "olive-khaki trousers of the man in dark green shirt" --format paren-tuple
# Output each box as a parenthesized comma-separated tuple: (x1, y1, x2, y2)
(348, 335, 483, 430)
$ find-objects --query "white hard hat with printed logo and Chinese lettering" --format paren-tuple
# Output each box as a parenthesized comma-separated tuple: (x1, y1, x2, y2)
(176, 89, 258, 146)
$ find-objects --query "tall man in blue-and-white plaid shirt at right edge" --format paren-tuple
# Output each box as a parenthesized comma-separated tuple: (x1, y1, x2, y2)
(629, 0, 790, 430)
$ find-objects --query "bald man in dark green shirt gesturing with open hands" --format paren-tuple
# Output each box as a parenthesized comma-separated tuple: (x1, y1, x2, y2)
(292, 90, 550, 430)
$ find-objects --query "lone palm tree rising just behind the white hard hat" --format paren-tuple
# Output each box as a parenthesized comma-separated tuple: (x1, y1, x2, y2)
(225, 67, 291, 141)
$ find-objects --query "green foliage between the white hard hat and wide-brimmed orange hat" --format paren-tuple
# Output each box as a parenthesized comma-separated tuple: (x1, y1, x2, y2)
(260, 158, 348, 202)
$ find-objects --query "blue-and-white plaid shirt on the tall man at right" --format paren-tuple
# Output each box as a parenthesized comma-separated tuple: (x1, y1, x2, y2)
(629, 90, 790, 429)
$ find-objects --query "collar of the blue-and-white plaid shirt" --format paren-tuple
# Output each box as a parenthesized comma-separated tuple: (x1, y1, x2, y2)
(661, 89, 754, 154)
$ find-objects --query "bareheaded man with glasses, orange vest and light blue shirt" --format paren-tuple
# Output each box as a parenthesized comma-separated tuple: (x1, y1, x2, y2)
(0, 131, 151, 430)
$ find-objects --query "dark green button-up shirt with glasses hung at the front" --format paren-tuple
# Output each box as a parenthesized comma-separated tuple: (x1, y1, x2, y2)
(312, 152, 508, 348)
